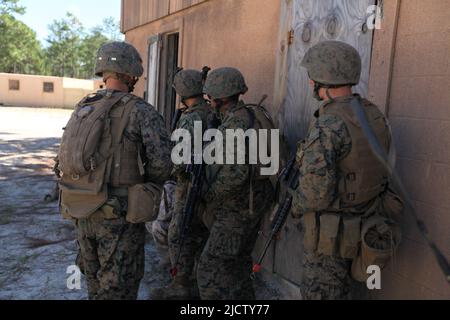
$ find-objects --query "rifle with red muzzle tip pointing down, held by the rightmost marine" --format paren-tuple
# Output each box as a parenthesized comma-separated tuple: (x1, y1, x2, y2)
(250, 157, 300, 280)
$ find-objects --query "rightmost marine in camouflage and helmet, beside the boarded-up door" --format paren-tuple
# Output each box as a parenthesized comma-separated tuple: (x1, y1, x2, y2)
(292, 41, 391, 300)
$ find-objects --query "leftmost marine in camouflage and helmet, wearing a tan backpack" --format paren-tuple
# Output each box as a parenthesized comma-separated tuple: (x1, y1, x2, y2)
(58, 42, 172, 300)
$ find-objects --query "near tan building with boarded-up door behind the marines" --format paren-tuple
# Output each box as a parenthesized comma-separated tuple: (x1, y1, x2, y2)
(121, 0, 450, 299)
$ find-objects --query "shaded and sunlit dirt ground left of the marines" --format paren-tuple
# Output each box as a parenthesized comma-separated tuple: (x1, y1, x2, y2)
(0, 107, 279, 300)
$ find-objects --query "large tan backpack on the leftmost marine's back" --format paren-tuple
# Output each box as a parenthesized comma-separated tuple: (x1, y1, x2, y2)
(58, 91, 136, 218)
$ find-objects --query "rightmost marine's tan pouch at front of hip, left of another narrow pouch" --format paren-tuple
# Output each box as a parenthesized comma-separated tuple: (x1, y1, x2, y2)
(317, 213, 341, 256)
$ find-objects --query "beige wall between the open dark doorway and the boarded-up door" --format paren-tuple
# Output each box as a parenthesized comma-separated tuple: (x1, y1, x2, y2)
(126, 0, 280, 110)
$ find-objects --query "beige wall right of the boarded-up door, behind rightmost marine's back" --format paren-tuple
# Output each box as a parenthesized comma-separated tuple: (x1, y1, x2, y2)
(371, 0, 450, 299)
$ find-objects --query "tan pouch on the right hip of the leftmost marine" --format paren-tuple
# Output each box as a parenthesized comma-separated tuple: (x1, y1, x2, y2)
(126, 183, 162, 224)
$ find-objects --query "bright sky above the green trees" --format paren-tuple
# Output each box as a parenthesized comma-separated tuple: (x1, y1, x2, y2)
(18, 0, 121, 44)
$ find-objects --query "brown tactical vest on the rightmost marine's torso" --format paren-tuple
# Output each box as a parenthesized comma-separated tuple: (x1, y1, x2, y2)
(320, 99, 391, 208)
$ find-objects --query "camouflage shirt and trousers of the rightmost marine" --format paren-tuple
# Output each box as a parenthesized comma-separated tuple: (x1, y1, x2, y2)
(291, 97, 392, 300)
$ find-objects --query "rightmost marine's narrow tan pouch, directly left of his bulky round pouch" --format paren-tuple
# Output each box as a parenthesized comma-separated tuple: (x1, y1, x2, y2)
(339, 217, 361, 259)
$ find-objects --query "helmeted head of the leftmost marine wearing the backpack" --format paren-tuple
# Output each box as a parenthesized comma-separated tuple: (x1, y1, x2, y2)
(95, 41, 144, 92)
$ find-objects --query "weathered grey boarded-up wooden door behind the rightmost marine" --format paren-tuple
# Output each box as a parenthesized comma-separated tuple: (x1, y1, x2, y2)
(273, 0, 375, 284)
